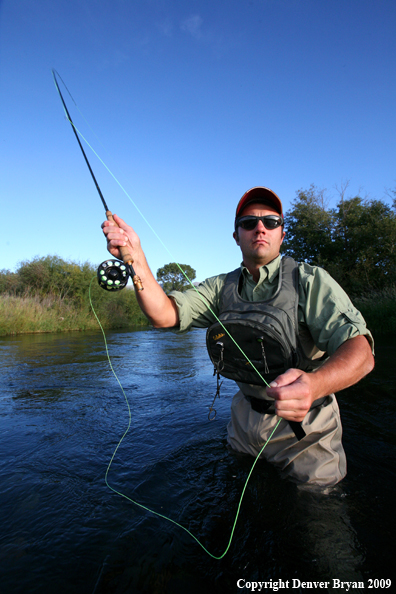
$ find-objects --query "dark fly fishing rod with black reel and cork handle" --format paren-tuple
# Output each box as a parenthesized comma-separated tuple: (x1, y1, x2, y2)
(52, 70, 143, 291)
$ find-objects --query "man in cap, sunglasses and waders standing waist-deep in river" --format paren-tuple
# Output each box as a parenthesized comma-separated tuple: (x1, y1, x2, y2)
(102, 187, 374, 487)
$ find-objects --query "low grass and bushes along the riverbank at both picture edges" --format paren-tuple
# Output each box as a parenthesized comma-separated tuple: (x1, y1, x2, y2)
(0, 256, 396, 336)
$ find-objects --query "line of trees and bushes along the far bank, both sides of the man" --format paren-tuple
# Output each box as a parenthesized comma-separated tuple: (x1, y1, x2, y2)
(0, 184, 396, 334)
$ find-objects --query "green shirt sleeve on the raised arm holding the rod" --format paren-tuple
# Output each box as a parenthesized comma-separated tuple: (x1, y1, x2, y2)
(169, 274, 227, 332)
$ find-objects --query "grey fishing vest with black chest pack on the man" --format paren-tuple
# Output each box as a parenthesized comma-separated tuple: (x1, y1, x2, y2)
(206, 256, 323, 440)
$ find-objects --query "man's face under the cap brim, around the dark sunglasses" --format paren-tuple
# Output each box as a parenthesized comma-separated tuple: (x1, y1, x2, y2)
(234, 203, 285, 269)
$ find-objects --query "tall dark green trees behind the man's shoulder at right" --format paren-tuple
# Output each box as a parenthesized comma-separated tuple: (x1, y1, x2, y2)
(282, 184, 396, 296)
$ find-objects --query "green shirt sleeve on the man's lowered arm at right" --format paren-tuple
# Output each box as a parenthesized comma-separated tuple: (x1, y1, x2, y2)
(299, 264, 374, 355)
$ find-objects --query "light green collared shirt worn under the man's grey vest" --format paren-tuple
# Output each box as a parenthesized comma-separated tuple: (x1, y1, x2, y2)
(169, 256, 374, 356)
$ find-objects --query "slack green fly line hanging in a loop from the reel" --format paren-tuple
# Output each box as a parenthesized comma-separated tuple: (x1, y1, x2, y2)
(89, 276, 282, 560)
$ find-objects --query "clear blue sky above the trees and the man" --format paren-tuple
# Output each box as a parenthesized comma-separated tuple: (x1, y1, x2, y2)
(0, 0, 396, 280)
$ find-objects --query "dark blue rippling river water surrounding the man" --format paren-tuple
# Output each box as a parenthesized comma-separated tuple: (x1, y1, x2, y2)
(0, 329, 396, 594)
